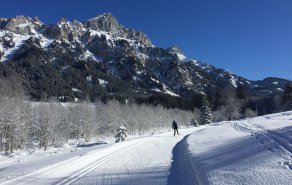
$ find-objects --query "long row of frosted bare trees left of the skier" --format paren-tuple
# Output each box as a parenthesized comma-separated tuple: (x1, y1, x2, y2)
(0, 97, 194, 153)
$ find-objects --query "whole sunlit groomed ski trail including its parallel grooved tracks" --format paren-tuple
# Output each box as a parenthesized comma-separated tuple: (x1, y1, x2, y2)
(3, 128, 198, 185)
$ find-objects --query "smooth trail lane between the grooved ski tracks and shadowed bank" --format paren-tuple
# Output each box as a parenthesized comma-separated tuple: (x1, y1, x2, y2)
(69, 128, 198, 185)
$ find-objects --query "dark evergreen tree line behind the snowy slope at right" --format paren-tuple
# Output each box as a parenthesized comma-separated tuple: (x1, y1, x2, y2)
(200, 82, 292, 124)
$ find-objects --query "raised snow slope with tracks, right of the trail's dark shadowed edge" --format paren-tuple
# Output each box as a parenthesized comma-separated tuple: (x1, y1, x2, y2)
(188, 112, 292, 185)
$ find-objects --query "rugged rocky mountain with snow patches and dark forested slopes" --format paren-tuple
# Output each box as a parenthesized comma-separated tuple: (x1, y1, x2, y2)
(0, 13, 287, 108)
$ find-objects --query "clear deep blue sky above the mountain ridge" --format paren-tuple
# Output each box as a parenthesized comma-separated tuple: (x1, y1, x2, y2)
(0, 0, 292, 80)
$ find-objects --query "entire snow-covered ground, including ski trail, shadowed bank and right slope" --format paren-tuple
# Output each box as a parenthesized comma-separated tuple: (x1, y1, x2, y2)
(0, 112, 292, 185)
